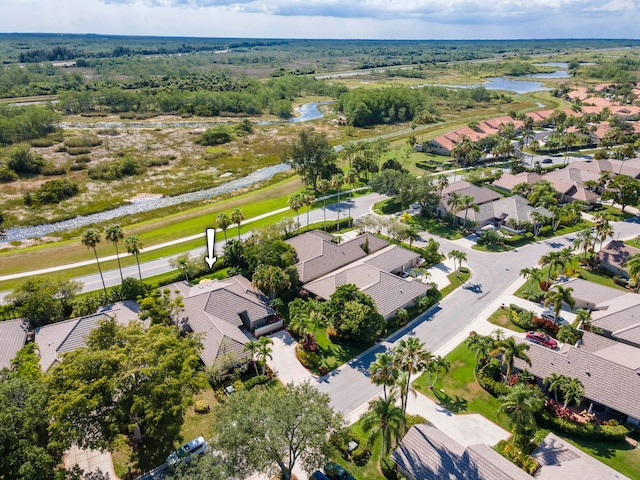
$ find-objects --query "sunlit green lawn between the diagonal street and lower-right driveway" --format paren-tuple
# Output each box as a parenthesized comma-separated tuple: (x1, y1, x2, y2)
(413, 343, 509, 430)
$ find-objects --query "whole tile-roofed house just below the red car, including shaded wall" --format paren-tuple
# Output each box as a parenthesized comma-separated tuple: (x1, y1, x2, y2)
(514, 332, 640, 425)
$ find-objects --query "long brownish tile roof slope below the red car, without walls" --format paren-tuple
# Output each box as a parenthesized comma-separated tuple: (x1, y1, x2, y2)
(514, 344, 640, 419)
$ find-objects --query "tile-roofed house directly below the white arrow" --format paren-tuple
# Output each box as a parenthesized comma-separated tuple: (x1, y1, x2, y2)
(169, 275, 283, 366)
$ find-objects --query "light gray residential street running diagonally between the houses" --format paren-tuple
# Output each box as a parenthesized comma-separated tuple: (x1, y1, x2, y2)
(318, 216, 640, 415)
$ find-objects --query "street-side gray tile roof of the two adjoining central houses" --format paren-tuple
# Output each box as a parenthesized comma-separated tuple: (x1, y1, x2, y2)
(303, 245, 430, 320)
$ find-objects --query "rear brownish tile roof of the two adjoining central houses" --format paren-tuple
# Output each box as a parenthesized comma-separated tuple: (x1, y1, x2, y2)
(287, 231, 389, 283)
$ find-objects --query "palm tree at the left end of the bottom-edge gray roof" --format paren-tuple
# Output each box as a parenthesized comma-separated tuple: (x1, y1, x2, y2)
(361, 395, 404, 459)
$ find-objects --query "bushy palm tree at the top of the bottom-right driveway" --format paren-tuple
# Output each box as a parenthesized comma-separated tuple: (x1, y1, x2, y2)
(498, 384, 543, 446)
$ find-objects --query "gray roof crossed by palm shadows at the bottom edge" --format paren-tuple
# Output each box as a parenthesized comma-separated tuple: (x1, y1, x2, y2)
(391, 424, 531, 480)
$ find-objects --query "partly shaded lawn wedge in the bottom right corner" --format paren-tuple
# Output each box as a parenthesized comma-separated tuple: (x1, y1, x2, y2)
(554, 432, 640, 480)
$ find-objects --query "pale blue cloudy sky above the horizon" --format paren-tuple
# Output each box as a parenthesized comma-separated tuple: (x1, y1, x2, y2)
(0, 0, 640, 39)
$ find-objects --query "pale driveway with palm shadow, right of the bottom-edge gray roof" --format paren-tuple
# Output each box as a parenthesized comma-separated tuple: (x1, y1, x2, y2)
(531, 433, 628, 480)
